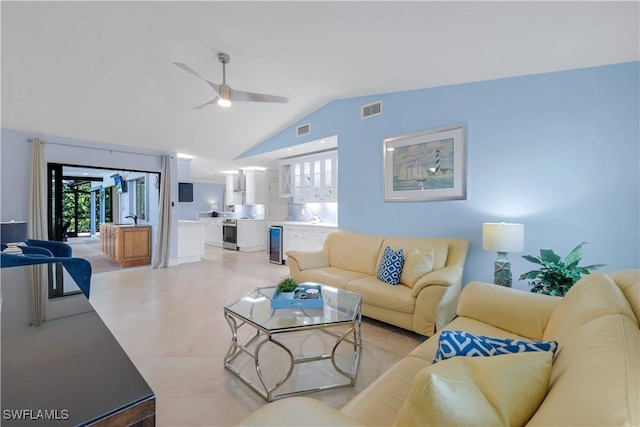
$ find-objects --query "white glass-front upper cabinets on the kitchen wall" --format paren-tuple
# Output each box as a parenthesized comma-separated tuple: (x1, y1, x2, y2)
(279, 150, 338, 203)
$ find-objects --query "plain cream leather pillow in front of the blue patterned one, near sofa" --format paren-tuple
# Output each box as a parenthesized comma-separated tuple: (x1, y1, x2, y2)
(394, 352, 553, 427)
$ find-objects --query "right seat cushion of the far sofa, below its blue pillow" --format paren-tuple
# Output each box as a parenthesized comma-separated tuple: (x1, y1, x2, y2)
(345, 276, 416, 314)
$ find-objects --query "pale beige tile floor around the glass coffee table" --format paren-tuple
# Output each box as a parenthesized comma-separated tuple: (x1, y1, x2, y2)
(86, 246, 424, 426)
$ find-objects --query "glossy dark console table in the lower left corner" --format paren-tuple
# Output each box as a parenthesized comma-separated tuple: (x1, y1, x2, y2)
(0, 266, 156, 427)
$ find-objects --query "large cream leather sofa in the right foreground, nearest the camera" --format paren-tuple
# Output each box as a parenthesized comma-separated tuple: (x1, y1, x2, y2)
(241, 270, 640, 426)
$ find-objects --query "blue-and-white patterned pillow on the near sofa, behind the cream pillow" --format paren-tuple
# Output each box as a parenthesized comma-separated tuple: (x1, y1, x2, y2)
(433, 331, 558, 363)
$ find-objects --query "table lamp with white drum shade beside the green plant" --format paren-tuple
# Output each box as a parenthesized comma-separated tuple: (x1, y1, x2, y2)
(482, 221, 524, 288)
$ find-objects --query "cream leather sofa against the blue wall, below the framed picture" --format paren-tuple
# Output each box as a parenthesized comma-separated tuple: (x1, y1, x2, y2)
(287, 230, 469, 336)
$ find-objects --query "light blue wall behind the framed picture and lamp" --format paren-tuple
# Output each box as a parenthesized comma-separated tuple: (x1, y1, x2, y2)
(245, 62, 640, 289)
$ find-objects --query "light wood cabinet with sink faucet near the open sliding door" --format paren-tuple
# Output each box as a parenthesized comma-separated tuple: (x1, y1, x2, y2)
(100, 223, 151, 267)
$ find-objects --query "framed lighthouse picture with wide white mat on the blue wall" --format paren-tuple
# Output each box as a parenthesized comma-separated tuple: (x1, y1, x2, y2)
(383, 125, 467, 202)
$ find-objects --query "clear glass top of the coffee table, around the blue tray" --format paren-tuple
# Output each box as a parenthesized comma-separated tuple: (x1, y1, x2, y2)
(224, 285, 362, 332)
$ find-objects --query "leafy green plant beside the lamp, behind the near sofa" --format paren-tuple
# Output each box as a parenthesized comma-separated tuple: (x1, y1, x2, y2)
(520, 242, 604, 297)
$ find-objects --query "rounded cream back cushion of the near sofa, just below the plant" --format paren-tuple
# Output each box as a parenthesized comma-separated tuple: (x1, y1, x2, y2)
(542, 272, 638, 342)
